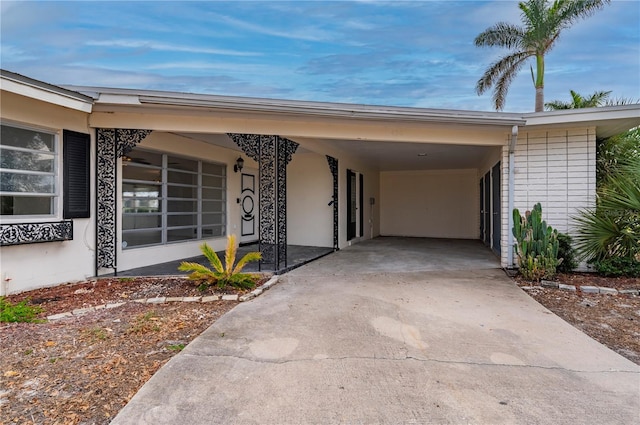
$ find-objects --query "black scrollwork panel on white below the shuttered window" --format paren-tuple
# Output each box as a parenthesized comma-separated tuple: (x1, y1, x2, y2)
(0, 220, 73, 246)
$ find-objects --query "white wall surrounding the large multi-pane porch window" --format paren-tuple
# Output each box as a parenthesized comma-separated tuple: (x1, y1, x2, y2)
(114, 132, 257, 273)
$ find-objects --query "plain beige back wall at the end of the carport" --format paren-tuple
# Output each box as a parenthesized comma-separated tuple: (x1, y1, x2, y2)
(380, 169, 480, 239)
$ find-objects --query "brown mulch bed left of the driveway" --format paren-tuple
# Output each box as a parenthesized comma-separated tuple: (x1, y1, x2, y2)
(0, 278, 262, 424)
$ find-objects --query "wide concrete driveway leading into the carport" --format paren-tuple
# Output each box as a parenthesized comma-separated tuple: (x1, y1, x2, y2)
(113, 238, 640, 425)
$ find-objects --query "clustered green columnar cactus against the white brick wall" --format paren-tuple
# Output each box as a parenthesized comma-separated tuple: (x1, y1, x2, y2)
(511, 203, 562, 280)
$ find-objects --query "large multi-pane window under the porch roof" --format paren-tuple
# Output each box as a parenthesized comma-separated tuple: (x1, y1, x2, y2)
(122, 149, 226, 248)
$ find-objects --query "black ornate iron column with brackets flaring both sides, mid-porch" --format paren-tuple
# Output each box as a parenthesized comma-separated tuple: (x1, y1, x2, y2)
(228, 133, 298, 271)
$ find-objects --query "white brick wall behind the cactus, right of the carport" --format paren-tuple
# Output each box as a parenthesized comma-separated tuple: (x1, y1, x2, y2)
(502, 127, 596, 267)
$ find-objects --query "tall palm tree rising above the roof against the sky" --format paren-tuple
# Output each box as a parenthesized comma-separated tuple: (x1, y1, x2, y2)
(475, 0, 611, 112)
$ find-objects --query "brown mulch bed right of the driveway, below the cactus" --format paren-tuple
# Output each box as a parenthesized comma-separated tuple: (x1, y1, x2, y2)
(516, 273, 640, 365)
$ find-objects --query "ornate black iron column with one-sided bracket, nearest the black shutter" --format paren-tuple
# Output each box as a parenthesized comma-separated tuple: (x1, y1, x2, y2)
(96, 128, 151, 275)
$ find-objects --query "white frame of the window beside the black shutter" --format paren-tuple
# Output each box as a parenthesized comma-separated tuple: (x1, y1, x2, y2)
(0, 119, 63, 224)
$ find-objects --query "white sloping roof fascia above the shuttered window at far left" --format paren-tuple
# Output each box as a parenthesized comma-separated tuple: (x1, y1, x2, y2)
(0, 70, 93, 113)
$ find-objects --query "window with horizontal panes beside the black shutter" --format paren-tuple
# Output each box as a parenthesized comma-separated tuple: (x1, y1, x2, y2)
(0, 124, 58, 217)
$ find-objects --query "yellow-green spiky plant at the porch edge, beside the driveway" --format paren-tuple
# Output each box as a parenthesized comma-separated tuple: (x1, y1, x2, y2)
(178, 235, 262, 289)
